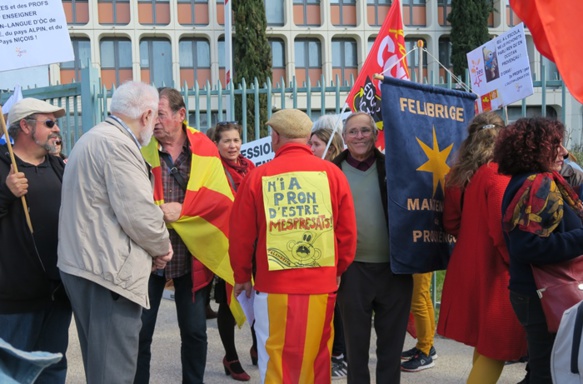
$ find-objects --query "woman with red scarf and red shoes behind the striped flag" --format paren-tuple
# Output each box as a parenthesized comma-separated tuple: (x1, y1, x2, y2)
(207, 122, 257, 381)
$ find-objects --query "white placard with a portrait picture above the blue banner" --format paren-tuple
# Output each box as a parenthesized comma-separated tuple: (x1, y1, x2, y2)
(467, 23, 534, 112)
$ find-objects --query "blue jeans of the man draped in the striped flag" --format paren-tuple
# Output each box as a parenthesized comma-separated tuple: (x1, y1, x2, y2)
(134, 273, 209, 384)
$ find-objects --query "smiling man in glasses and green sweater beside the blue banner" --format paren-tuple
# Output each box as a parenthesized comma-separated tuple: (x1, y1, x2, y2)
(333, 112, 413, 383)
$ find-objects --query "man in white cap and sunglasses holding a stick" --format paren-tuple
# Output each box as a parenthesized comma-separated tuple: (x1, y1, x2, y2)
(0, 98, 71, 383)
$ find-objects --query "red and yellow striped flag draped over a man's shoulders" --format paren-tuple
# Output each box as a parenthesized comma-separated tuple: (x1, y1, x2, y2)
(142, 126, 245, 326)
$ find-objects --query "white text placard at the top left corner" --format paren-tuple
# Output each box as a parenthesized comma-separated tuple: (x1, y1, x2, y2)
(0, 0, 75, 71)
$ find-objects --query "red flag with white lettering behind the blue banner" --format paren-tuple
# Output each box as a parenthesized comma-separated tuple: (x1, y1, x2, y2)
(346, 0, 409, 150)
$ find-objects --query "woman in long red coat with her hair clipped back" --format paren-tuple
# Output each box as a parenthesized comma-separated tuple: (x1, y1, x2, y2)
(437, 112, 526, 383)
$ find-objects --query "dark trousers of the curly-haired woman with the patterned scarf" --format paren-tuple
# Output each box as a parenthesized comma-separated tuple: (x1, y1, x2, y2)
(510, 291, 556, 384)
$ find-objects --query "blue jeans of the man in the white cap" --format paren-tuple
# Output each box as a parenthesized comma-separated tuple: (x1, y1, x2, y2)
(0, 301, 72, 384)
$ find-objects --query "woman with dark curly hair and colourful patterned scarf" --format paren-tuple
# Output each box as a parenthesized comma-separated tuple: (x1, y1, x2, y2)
(494, 118, 583, 384)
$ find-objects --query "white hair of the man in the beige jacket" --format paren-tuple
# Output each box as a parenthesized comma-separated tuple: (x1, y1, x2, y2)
(110, 81, 160, 119)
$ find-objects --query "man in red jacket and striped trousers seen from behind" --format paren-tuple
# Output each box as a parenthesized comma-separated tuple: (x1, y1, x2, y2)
(229, 109, 356, 383)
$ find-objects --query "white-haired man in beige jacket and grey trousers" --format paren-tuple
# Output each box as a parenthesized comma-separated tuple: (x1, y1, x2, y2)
(57, 82, 172, 384)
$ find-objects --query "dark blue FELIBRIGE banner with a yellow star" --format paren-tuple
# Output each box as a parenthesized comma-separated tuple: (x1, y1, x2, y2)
(381, 77, 476, 273)
